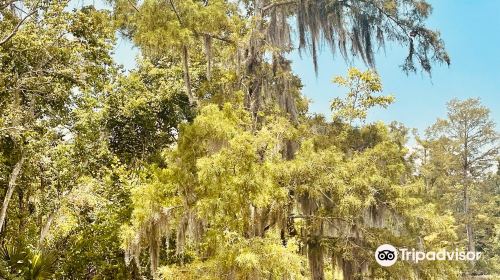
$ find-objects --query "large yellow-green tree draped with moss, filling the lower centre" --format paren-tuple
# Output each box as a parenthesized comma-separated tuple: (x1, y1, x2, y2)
(117, 69, 459, 279)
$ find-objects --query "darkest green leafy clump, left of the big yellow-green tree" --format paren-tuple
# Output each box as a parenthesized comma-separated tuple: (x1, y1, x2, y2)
(102, 62, 192, 162)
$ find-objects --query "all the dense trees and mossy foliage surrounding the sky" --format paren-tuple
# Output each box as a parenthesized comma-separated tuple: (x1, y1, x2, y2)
(0, 0, 500, 279)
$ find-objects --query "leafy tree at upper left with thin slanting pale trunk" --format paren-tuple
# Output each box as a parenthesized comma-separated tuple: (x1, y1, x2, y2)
(0, 1, 112, 230)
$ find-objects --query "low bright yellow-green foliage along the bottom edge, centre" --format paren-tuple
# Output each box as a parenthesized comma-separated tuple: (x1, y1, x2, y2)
(160, 232, 307, 280)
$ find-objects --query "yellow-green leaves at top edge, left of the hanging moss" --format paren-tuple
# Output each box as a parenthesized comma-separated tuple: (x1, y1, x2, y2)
(115, 0, 234, 54)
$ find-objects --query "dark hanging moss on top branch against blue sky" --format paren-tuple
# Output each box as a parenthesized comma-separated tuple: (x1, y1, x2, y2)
(266, 0, 450, 73)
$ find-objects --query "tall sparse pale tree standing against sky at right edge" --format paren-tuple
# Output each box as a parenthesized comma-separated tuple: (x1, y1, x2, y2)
(419, 99, 500, 274)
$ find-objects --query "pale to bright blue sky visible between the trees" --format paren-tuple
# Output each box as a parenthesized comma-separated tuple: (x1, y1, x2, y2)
(110, 0, 500, 131)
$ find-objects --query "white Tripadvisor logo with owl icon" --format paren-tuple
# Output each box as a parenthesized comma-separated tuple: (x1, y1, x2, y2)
(375, 244, 481, 266)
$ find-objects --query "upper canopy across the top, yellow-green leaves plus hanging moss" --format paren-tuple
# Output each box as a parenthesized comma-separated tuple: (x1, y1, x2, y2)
(113, 0, 450, 118)
